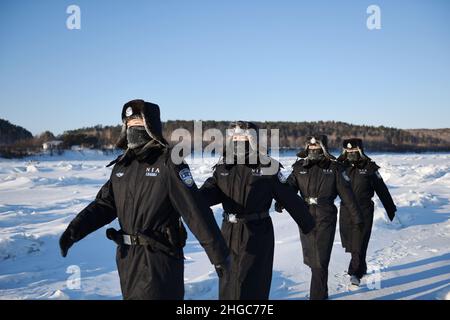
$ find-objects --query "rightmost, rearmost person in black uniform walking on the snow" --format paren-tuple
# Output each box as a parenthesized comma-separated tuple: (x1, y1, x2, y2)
(338, 138, 397, 285)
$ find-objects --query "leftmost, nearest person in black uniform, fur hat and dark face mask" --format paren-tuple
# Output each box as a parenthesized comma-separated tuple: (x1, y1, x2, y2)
(60, 100, 229, 299)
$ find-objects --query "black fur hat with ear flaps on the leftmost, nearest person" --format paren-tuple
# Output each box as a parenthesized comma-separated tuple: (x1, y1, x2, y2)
(116, 99, 169, 149)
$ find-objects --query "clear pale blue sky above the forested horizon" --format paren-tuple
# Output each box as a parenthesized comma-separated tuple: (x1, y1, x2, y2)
(0, 0, 450, 134)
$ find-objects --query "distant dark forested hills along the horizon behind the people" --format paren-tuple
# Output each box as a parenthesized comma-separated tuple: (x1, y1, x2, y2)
(0, 119, 450, 157)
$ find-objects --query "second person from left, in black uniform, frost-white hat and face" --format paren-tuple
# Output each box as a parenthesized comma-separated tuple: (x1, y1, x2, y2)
(200, 121, 314, 300)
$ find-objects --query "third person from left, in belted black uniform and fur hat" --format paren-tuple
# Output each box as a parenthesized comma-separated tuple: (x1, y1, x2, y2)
(275, 135, 362, 300)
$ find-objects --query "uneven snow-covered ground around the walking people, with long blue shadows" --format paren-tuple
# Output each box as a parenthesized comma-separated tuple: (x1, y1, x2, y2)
(0, 152, 450, 299)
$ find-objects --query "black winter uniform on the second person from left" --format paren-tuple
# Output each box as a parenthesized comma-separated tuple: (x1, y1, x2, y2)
(200, 160, 314, 300)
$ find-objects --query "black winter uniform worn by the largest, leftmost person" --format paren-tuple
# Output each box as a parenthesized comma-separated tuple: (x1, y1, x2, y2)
(63, 148, 228, 299)
